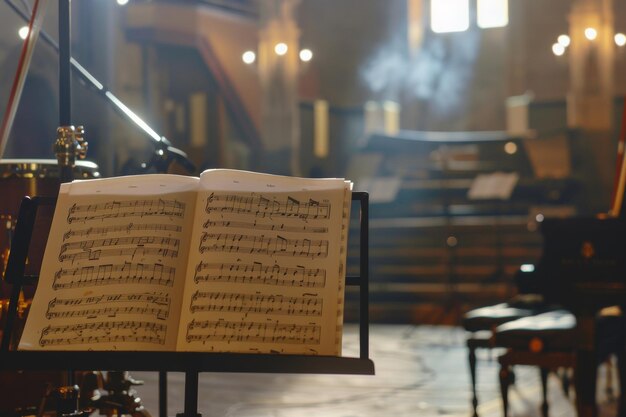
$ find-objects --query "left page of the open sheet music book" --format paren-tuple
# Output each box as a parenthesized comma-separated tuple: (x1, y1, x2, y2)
(19, 175, 198, 350)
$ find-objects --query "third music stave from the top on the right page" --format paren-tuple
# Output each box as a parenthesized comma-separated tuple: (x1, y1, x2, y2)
(198, 232, 328, 259)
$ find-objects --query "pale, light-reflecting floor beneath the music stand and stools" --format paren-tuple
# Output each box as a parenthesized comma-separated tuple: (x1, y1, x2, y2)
(132, 325, 615, 417)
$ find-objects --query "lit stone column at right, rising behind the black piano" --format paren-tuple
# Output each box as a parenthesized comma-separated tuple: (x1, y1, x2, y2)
(567, 0, 617, 214)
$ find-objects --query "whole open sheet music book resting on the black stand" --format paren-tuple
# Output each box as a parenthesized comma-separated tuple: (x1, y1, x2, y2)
(19, 170, 351, 356)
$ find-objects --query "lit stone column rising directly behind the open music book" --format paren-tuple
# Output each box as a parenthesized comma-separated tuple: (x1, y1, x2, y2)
(258, 0, 301, 175)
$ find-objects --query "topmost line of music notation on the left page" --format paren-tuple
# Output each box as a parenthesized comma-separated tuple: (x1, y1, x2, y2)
(67, 198, 185, 224)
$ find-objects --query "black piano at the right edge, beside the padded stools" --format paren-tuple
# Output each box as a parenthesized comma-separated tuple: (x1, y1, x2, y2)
(537, 216, 626, 417)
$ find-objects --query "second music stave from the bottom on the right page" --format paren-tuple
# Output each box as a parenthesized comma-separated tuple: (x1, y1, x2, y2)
(189, 291, 323, 316)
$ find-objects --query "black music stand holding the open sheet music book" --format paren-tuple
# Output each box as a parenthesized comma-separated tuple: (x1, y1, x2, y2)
(0, 192, 374, 417)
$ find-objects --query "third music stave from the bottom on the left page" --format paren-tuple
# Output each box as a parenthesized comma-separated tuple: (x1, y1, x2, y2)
(52, 262, 176, 290)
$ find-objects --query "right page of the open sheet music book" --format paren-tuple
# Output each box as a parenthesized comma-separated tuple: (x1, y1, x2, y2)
(178, 170, 351, 355)
